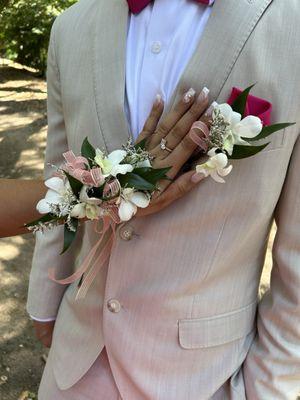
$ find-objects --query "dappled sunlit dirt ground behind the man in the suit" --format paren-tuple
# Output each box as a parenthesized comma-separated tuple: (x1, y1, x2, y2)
(0, 59, 275, 400)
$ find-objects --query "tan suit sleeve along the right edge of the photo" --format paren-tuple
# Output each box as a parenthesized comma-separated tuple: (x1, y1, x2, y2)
(244, 136, 300, 400)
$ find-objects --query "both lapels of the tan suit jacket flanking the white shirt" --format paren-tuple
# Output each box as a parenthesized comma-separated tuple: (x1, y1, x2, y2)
(93, 0, 272, 151)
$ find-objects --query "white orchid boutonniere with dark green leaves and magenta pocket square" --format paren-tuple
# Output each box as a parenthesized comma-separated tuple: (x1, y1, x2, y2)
(193, 85, 294, 183)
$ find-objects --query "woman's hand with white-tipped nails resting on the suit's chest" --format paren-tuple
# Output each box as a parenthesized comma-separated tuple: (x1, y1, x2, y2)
(136, 89, 211, 217)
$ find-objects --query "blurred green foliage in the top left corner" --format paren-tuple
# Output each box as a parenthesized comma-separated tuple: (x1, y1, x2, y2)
(0, 0, 76, 75)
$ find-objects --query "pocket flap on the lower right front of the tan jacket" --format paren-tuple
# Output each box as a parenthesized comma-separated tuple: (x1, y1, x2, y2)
(178, 301, 257, 349)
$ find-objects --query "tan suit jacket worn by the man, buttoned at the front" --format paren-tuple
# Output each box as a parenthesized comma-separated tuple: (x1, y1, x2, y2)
(28, 0, 300, 400)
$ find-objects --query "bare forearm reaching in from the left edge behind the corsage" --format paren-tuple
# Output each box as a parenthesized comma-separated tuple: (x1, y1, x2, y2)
(0, 179, 46, 237)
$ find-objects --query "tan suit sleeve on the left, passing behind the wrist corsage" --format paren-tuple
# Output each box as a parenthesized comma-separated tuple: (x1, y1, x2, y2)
(27, 20, 75, 319)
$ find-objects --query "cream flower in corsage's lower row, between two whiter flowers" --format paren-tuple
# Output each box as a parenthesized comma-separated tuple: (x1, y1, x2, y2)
(70, 185, 101, 219)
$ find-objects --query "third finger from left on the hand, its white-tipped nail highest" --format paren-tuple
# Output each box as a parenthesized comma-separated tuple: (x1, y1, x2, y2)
(154, 87, 209, 158)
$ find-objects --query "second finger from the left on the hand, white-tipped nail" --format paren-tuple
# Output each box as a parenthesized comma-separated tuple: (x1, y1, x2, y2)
(149, 88, 196, 149)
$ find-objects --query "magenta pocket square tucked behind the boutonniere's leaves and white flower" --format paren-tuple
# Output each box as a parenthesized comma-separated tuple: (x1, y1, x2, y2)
(227, 87, 272, 125)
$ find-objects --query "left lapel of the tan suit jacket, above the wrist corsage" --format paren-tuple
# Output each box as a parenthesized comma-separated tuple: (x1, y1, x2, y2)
(93, 0, 129, 151)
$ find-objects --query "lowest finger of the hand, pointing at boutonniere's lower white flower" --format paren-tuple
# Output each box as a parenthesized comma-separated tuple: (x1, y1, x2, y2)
(138, 171, 204, 216)
